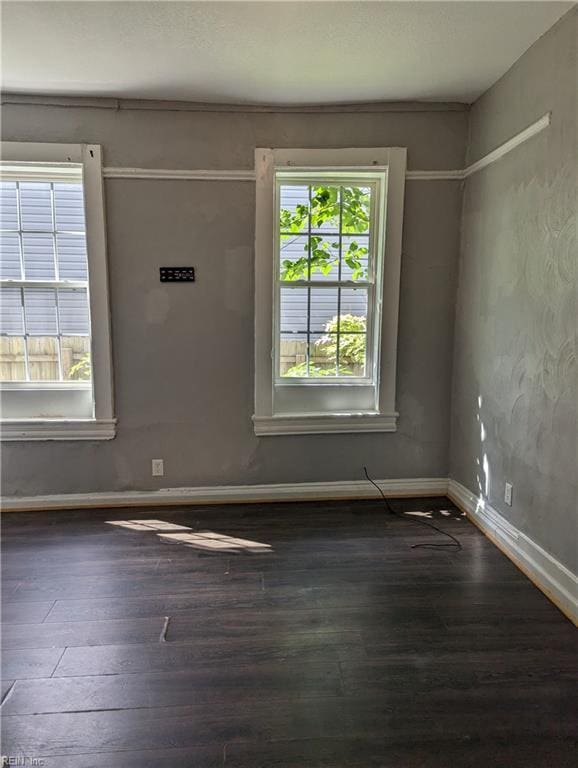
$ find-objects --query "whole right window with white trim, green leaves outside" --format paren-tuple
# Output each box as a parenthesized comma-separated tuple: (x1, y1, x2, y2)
(253, 149, 405, 435)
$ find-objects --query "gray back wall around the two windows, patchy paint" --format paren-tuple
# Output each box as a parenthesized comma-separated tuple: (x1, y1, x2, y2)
(2, 102, 467, 495)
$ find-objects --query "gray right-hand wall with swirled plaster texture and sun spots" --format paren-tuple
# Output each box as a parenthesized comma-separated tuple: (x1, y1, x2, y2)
(450, 10, 578, 571)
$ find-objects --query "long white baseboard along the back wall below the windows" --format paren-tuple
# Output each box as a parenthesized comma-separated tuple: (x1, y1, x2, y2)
(1, 477, 448, 512)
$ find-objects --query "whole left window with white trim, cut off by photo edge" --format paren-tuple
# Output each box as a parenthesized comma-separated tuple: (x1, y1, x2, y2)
(0, 142, 114, 440)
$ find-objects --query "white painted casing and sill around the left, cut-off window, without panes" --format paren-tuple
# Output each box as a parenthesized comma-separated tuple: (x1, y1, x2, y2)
(0, 141, 116, 441)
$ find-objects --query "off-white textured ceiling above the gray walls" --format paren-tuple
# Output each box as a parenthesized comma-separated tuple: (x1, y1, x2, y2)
(2, 0, 572, 104)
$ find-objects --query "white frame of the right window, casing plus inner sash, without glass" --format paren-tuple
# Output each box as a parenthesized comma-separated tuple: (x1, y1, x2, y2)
(253, 147, 406, 436)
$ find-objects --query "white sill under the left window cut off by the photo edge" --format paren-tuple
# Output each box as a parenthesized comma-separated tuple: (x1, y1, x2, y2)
(0, 419, 116, 441)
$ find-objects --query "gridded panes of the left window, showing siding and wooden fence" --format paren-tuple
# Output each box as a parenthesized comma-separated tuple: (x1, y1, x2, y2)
(0, 177, 92, 388)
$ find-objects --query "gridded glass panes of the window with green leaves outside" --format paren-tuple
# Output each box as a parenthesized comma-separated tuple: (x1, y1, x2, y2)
(274, 170, 382, 385)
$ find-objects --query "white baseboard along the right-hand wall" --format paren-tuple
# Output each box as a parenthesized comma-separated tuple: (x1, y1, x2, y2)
(448, 480, 578, 624)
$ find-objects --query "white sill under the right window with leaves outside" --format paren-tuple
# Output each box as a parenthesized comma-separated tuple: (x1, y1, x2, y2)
(253, 413, 398, 437)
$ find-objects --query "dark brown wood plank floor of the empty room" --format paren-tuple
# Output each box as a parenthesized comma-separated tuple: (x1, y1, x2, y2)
(2, 499, 578, 768)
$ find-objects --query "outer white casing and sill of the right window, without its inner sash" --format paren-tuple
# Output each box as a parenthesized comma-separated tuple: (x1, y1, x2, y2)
(253, 147, 406, 436)
